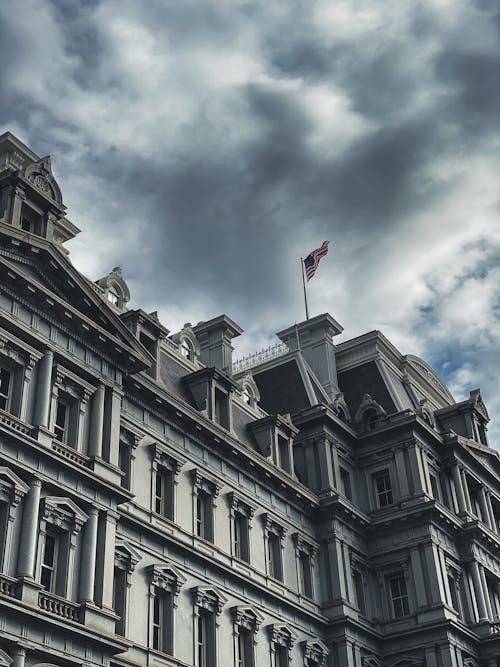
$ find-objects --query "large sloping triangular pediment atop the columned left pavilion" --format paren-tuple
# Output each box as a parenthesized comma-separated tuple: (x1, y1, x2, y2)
(0, 244, 153, 372)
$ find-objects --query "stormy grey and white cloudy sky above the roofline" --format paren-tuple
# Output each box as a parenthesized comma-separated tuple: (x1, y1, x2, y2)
(0, 0, 500, 447)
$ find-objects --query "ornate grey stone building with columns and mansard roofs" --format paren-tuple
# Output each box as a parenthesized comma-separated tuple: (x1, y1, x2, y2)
(0, 133, 500, 667)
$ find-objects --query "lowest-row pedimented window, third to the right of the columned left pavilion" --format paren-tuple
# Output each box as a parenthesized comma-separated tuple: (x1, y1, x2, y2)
(192, 586, 226, 667)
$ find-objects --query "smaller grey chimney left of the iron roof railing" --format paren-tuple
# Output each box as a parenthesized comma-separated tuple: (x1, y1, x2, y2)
(193, 315, 243, 375)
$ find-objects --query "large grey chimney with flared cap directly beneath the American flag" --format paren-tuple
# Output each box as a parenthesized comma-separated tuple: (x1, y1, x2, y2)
(276, 313, 343, 401)
